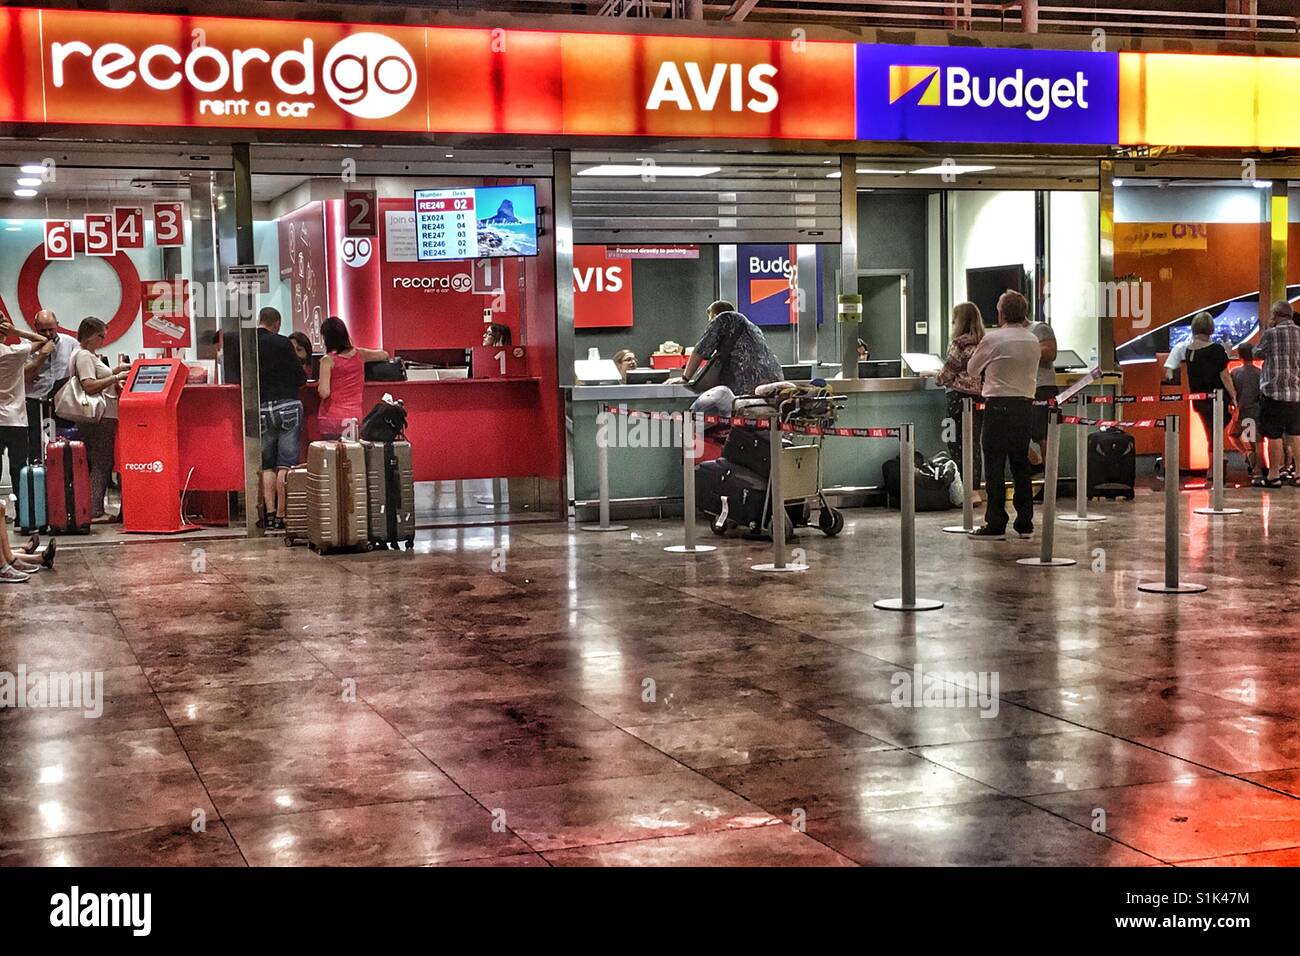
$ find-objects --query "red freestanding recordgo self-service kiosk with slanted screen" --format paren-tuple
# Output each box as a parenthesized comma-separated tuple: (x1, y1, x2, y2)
(117, 359, 198, 535)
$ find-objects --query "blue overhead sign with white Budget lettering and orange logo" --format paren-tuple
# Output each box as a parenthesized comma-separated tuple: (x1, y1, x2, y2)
(858, 44, 1119, 144)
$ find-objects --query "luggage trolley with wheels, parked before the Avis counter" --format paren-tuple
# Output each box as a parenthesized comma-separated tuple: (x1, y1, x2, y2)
(697, 385, 845, 537)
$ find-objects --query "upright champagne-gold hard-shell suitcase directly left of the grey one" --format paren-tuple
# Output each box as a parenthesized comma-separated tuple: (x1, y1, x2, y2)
(307, 441, 371, 553)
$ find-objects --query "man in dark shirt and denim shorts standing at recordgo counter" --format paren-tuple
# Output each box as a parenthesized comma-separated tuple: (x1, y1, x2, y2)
(257, 307, 307, 529)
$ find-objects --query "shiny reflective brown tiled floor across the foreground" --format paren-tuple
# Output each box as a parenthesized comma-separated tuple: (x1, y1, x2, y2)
(0, 489, 1300, 866)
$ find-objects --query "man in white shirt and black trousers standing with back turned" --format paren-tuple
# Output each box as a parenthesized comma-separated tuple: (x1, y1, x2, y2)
(966, 291, 1043, 540)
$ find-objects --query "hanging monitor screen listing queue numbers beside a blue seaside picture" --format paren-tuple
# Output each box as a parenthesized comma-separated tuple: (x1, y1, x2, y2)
(415, 186, 537, 263)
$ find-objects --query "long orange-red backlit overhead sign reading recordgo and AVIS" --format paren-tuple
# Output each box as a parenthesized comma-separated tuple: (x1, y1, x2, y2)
(0, 9, 854, 140)
